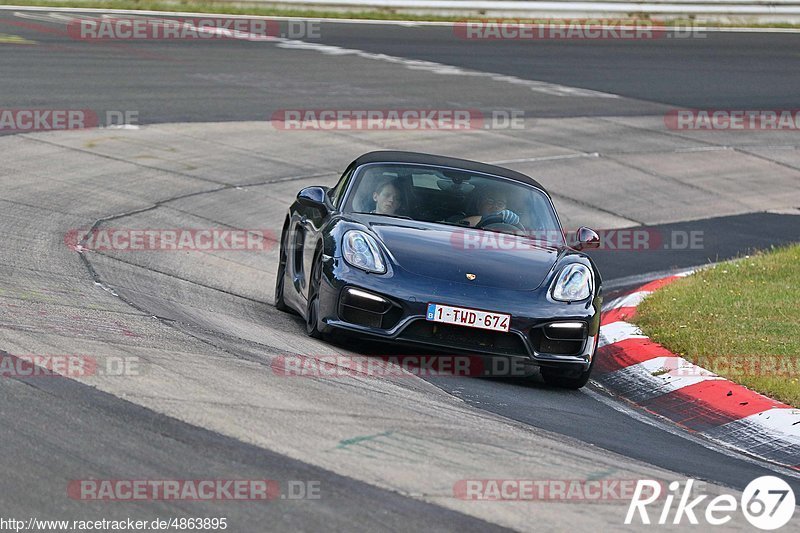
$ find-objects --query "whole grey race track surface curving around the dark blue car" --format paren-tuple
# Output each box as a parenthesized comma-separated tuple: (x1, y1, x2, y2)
(0, 9, 800, 531)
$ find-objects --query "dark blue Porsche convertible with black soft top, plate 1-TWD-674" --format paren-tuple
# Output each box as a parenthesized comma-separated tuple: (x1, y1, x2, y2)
(275, 151, 602, 388)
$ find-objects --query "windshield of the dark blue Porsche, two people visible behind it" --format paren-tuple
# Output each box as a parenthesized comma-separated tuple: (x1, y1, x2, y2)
(343, 164, 564, 244)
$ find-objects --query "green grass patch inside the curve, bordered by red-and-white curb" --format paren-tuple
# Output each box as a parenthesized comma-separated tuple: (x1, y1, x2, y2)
(635, 245, 800, 407)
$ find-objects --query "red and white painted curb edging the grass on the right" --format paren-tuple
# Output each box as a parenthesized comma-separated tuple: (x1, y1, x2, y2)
(592, 272, 800, 470)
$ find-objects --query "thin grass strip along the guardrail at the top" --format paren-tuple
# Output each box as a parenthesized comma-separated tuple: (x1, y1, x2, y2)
(8, 0, 800, 29)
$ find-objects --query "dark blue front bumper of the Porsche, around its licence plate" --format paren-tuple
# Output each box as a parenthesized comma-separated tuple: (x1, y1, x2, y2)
(320, 257, 602, 370)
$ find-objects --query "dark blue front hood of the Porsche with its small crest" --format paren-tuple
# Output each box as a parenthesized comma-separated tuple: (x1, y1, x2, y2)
(368, 220, 563, 290)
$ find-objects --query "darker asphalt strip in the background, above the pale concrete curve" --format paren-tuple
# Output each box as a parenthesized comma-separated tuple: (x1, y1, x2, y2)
(0, 10, 800, 124)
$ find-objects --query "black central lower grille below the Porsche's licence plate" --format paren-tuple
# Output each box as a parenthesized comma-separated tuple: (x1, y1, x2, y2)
(400, 320, 528, 356)
